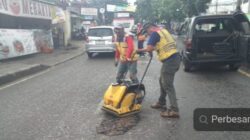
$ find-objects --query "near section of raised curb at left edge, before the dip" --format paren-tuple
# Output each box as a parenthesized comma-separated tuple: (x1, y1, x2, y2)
(0, 64, 50, 85)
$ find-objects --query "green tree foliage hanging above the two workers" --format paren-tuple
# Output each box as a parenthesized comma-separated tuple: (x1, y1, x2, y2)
(136, 0, 211, 23)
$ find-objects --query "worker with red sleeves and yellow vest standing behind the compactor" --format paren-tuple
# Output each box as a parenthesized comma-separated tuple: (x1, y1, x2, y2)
(115, 26, 139, 84)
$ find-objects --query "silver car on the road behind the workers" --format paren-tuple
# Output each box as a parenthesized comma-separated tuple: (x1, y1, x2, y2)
(86, 26, 115, 58)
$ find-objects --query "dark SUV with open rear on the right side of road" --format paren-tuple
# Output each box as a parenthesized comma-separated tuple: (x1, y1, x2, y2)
(178, 12, 250, 71)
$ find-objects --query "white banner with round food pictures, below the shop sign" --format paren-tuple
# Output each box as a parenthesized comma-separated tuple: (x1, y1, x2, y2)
(0, 29, 53, 60)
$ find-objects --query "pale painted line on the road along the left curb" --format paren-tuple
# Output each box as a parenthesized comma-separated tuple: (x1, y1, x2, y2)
(0, 68, 51, 90)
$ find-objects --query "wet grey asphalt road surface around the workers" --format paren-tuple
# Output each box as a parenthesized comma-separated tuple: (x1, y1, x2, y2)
(0, 52, 250, 140)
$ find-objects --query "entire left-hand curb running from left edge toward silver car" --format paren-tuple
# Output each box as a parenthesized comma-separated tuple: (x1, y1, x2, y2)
(0, 51, 85, 86)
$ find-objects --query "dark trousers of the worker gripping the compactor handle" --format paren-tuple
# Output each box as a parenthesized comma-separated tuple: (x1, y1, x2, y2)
(159, 54, 181, 112)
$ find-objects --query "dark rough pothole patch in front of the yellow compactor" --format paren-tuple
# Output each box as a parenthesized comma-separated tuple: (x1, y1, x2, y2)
(96, 115, 140, 136)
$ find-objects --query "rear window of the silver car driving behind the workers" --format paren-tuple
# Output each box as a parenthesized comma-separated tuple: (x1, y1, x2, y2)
(88, 28, 113, 37)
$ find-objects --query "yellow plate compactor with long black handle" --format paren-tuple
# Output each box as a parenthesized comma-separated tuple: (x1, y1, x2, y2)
(102, 57, 152, 117)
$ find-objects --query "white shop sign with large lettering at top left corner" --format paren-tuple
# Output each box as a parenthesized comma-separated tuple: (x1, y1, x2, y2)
(0, 0, 52, 19)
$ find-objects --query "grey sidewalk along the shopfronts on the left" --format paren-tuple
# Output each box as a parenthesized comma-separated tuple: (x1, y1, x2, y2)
(0, 41, 84, 85)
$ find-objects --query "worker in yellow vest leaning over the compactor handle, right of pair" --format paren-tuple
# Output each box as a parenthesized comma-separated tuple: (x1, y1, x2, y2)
(137, 23, 181, 118)
